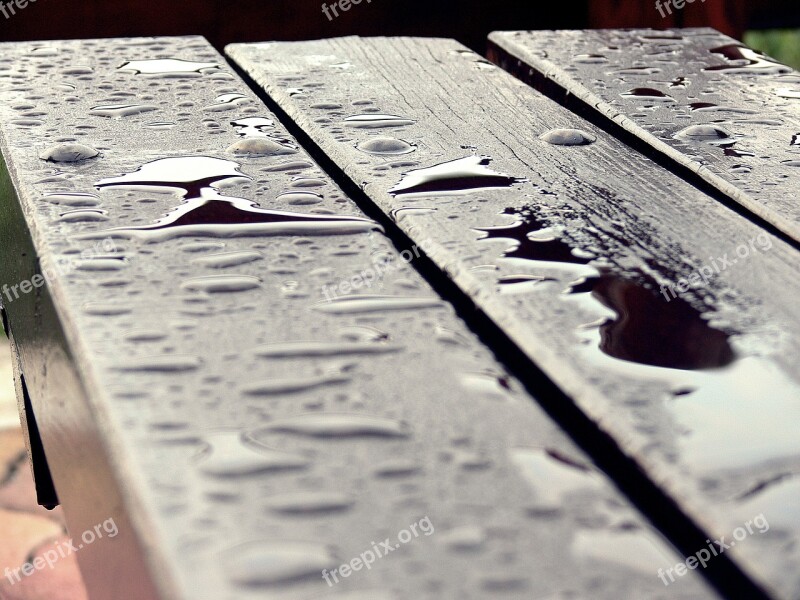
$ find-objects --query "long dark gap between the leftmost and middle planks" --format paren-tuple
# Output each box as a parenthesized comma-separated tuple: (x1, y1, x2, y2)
(226, 57, 769, 600)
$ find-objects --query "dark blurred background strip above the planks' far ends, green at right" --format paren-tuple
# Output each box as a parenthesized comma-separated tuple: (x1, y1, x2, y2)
(0, 0, 800, 67)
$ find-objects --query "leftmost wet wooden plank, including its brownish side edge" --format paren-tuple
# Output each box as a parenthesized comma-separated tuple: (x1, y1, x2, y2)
(0, 38, 713, 600)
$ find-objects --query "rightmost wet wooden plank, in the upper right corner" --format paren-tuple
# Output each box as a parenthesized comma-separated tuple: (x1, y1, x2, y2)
(489, 28, 800, 241)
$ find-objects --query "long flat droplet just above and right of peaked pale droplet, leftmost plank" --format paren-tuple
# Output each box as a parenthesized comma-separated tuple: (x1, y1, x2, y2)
(253, 413, 411, 439)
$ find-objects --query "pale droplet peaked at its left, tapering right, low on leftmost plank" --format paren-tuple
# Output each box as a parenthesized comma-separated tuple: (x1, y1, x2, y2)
(198, 432, 310, 477)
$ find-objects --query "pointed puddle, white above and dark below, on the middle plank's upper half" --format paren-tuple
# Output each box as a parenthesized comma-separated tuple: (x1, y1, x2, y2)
(389, 156, 525, 196)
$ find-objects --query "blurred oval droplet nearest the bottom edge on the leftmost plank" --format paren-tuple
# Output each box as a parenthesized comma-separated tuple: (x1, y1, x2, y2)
(223, 542, 339, 587)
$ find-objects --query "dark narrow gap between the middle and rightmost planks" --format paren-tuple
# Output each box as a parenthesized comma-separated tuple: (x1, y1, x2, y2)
(487, 40, 800, 250)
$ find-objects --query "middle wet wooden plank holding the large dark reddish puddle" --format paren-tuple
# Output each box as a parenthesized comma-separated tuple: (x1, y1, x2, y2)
(227, 38, 800, 597)
